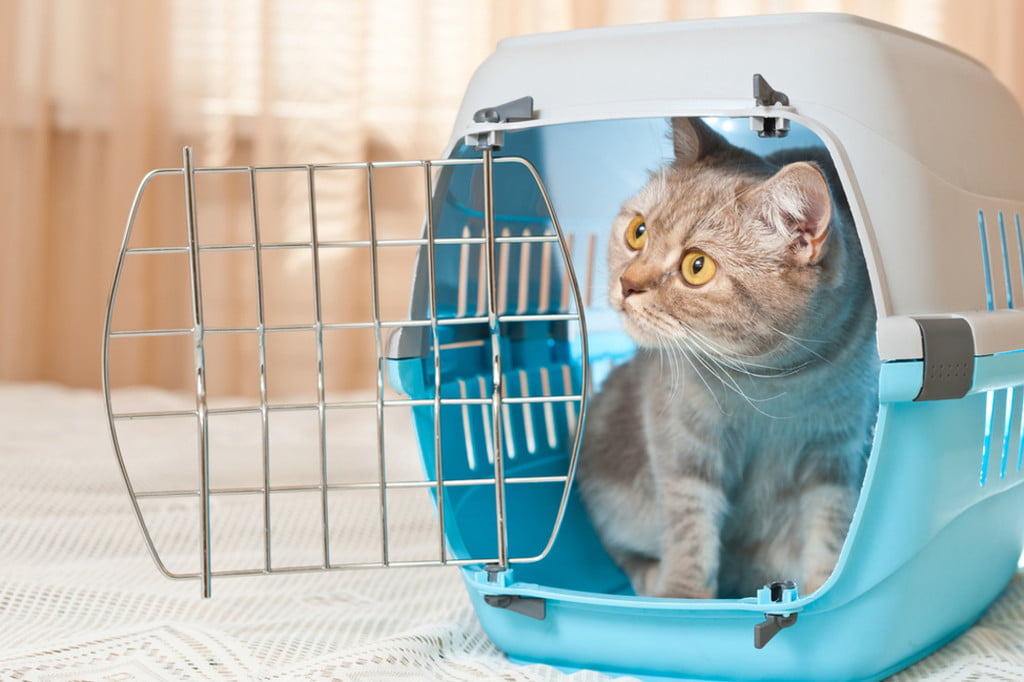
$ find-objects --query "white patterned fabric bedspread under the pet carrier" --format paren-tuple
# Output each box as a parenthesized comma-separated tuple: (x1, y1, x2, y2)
(0, 384, 1024, 682)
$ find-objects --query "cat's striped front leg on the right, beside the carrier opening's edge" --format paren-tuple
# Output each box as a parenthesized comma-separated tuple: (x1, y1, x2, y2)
(800, 483, 857, 594)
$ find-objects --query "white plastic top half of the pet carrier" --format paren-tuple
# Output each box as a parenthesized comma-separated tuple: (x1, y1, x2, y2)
(452, 14, 1024, 357)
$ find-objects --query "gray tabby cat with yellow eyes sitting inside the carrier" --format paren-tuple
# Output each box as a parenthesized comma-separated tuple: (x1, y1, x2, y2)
(578, 118, 879, 598)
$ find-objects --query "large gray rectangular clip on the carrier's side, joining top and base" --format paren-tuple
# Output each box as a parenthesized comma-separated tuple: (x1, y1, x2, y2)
(914, 317, 974, 400)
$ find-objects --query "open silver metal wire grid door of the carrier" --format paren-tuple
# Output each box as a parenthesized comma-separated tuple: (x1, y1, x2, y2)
(102, 146, 590, 597)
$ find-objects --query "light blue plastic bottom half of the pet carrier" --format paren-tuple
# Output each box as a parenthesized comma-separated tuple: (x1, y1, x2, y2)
(448, 353, 1024, 680)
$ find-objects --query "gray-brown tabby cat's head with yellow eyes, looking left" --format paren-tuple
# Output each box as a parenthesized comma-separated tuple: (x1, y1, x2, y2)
(608, 119, 833, 357)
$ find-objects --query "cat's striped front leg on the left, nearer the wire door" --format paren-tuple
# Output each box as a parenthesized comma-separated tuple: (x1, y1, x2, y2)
(654, 476, 727, 599)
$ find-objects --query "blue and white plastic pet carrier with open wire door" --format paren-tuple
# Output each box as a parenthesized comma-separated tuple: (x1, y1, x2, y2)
(104, 14, 1024, 680)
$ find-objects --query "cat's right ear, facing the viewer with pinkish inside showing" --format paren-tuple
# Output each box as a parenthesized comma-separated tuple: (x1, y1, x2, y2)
(752, 161, 831, 265)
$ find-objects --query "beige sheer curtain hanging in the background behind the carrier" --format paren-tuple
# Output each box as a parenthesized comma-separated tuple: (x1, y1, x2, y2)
(0, 0, 1024, 395)
